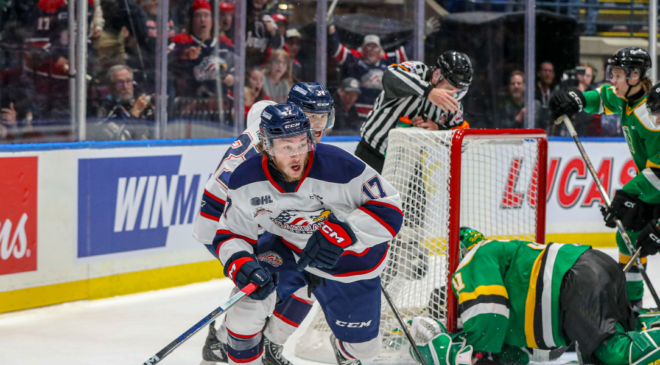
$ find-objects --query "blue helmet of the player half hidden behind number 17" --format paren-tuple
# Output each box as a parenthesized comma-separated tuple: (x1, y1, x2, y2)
(287, 82, 335, 132)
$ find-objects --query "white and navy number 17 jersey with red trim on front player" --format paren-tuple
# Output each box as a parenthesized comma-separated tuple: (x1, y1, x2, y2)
(213, 143, 403, 283)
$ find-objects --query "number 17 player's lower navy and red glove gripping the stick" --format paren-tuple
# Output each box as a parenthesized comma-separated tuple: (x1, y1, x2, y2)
(225, 251, 277, 300)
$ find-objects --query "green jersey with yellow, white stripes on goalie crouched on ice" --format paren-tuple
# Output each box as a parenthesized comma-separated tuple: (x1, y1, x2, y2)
(452, 240, 591, 353)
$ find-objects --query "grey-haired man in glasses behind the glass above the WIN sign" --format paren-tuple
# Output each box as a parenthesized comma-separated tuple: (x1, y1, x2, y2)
(88, 65, 154, 140)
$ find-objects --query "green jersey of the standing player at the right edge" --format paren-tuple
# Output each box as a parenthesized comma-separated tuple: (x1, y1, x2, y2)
(583, 85, 660, 204)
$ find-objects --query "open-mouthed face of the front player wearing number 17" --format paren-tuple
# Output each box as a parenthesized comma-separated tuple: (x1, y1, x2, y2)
(272, 134, 310, 181)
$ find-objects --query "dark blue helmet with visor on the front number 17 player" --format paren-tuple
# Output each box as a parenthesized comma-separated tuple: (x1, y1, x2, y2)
(259, 102, 316, 156)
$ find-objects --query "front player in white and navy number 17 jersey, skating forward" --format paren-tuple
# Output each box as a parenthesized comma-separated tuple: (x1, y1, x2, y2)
(213, 103, 403, 365)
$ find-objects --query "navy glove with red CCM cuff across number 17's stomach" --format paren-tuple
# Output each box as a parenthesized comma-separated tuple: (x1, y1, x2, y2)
(298, 213, 357, 271)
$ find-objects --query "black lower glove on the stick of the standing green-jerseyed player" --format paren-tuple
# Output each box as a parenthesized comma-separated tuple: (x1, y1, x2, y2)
(600, 190, 647, 230)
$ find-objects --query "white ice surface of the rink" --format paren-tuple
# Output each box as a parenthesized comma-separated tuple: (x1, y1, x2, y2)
(0, 249, 660, 365)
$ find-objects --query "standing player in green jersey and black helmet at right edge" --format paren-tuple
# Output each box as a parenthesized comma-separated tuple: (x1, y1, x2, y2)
(550, 47, 660, 308)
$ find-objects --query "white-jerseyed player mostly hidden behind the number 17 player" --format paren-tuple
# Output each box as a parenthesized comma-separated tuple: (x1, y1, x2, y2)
(193, 82, 334, 365)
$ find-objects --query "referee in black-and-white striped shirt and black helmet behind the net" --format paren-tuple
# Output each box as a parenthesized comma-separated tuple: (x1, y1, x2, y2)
(355, 51, 473, 173)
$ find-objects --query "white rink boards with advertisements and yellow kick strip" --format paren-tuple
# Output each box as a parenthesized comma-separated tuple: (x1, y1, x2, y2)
(0, 137, 635, 313)
